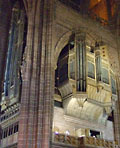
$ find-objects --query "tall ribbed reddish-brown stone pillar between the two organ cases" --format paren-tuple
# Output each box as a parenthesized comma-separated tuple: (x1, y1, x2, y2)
(18, 0, 54, 148)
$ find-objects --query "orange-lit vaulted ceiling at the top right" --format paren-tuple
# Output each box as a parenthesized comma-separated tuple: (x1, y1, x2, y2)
(72, 0, 117, 20)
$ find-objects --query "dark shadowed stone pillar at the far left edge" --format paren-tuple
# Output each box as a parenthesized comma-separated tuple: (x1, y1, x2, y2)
(0, 0, 12, 100)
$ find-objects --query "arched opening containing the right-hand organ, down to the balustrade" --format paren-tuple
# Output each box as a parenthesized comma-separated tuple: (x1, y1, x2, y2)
(53, 32, 117, 145)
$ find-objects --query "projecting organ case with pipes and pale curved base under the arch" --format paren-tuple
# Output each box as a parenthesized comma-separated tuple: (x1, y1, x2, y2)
(55, 32, 117, 128)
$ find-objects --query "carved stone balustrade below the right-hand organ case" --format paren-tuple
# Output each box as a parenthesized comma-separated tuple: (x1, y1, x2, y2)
(53, 133, 118, 148)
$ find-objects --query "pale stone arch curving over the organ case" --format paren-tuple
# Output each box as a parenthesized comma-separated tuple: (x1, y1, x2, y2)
(53, 27, 119, 74)
